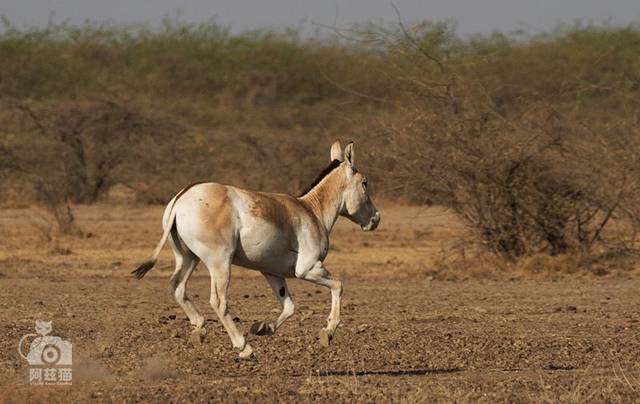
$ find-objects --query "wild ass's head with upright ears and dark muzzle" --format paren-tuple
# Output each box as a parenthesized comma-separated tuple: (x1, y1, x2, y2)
(331, 142, 380, 231)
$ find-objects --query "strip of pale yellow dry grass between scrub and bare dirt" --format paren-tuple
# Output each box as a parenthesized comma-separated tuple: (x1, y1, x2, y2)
(0, 200, 640, 280)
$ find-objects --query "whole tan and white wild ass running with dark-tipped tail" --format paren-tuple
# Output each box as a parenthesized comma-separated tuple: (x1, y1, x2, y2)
(132, 142, 380, 358)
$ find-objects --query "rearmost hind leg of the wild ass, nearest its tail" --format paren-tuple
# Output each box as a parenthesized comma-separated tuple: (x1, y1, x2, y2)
(169, 227, 204, 329)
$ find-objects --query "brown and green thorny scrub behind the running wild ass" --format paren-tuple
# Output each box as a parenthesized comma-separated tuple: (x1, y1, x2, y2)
(0, 20, 640, 273)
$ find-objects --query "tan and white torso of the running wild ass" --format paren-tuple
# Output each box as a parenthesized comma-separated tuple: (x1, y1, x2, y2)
(170, 183, 322, 277)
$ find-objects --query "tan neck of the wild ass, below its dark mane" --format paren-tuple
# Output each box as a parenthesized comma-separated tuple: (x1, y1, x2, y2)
(300, 169, 345, 233)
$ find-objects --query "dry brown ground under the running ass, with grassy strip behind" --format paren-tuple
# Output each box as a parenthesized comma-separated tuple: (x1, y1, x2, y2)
(0, 204, 640, 403)
